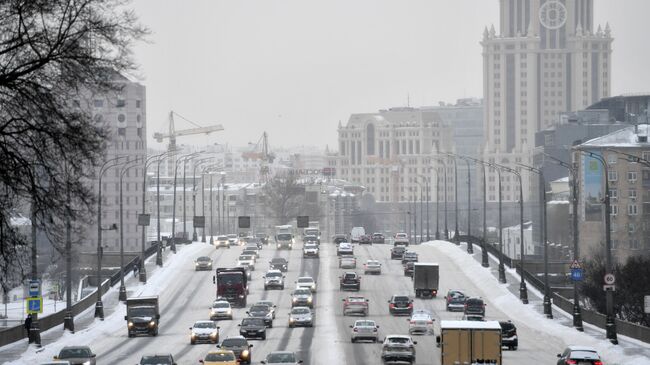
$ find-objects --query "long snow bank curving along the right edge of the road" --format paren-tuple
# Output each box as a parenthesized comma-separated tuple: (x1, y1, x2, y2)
(423, 241, 650, 365)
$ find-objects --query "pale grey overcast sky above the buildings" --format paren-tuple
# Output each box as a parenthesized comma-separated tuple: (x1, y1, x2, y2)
(132, 0, 650, 148)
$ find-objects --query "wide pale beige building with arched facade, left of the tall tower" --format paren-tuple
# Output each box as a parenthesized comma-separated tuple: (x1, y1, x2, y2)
(327, 107, 454, 202)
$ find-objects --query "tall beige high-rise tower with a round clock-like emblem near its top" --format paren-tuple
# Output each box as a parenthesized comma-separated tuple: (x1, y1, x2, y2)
(481, 0, 612, 201)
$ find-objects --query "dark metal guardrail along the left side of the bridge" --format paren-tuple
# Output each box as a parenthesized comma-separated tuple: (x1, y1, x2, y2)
(0, 243, 158, 347)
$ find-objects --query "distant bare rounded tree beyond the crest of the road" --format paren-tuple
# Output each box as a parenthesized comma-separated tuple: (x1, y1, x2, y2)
(262, 174, 305, 224)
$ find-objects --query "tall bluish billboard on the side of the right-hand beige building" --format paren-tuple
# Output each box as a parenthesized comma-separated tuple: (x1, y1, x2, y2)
(582, 152, 604, 222)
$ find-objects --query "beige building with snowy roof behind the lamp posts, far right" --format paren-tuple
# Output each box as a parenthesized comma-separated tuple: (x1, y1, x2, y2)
(574, 124, 650, 262)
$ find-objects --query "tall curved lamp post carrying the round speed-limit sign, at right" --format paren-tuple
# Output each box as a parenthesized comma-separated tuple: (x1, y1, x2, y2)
(579, 150, 618, 345)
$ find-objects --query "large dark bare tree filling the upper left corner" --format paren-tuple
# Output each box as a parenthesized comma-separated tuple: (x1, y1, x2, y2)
(0, 0, 147, 287)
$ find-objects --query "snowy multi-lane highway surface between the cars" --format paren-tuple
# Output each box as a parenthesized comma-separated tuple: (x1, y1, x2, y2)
(6, 235, 636, 364)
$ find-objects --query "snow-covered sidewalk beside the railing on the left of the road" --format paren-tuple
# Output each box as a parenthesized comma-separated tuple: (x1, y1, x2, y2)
(0, 250, 171, 363)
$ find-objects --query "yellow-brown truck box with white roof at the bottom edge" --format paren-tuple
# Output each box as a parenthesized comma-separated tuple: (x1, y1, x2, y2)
(436, 321, 502, 365)
